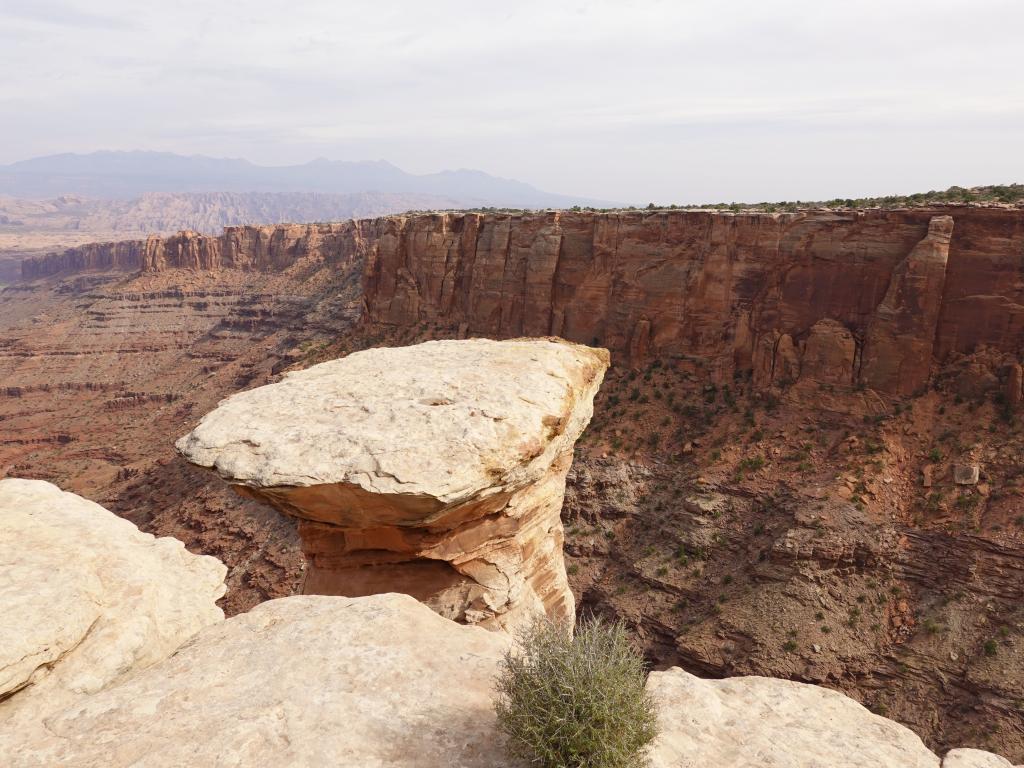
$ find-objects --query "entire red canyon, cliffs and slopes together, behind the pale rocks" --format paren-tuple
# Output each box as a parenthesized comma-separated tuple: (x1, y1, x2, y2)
(0, 206, 1024, 762)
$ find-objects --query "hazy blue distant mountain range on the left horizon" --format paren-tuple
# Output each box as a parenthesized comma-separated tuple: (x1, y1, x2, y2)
(0, 152, 611, 208)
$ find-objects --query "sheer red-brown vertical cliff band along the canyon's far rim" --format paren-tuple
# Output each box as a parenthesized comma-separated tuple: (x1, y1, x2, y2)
(23, 207, 1024, 394)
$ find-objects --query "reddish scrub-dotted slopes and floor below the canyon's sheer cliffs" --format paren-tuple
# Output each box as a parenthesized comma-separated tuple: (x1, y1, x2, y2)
(0, 211, 1024, 762)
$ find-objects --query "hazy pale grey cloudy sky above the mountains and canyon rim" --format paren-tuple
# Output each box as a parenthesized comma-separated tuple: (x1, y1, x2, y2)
(0, 0, 1024, 203)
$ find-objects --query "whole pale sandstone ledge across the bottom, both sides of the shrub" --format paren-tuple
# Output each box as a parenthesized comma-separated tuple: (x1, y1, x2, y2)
(9, 479, 1013, 768)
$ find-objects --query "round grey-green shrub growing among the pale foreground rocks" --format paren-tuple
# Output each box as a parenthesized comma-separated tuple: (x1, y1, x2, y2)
(495, 618, 657, 768)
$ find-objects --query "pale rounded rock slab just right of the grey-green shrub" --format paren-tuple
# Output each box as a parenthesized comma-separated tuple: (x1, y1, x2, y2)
(647, 668, 939, 768)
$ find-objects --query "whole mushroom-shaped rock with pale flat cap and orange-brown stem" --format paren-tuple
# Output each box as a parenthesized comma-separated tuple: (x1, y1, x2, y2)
(177, 339, 608, 629)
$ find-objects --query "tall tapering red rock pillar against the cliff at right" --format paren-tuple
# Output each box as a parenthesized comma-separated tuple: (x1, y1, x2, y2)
(861, 216, 953, 395)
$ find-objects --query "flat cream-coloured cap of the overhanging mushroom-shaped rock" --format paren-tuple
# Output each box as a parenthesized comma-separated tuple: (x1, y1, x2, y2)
(176, 339, 608, 512)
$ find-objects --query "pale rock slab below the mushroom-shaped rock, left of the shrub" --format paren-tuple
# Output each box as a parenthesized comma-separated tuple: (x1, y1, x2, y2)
(7, 594, 514, 768)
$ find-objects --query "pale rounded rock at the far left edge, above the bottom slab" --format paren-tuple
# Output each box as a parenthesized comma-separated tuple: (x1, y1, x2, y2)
(0, 478, 225, 731)
